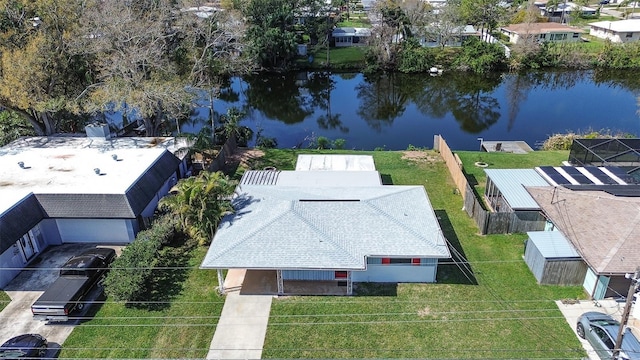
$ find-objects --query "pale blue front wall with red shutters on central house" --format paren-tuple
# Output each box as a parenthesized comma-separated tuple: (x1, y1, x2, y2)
(351, 259, 438, 283)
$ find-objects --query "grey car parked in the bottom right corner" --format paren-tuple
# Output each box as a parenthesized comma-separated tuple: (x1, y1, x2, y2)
(576, 311, 640, 360)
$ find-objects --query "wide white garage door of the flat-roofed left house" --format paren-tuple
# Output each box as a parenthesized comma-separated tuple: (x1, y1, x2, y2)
(55, 219, 136, 243)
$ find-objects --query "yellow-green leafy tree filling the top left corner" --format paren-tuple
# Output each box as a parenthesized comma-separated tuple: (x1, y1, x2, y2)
(0, 0, 92, 135)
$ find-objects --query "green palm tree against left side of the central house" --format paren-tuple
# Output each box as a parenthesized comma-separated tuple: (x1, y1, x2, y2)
(159, 171, 236, 245)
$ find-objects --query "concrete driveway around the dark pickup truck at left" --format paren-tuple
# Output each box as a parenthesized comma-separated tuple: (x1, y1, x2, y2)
(0, 244, 120, 357)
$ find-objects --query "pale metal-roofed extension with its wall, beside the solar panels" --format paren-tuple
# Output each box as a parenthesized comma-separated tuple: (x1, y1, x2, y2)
(484, 169, 549, 212)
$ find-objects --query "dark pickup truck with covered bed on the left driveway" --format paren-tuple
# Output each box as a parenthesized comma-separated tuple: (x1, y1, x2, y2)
(31, 248, 116, 321)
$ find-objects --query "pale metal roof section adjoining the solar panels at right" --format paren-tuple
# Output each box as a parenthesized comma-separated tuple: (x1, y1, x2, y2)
(484, 169, 549, 210)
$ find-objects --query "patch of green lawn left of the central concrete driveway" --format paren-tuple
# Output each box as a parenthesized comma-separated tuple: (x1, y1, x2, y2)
(60, 248, 224, 359)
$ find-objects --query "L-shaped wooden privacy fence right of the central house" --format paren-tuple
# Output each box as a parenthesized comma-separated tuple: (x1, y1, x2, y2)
(433, 135, 545, 235)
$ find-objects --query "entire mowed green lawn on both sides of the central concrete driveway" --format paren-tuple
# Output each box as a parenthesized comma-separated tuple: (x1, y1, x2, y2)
(55, 150, 585, 359)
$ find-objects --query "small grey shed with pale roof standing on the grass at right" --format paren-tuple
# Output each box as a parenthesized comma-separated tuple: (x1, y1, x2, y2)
(524, 231, 587, 285)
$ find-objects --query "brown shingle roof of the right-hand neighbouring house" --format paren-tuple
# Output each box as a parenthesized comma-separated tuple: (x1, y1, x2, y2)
(527, 187, 640, 275)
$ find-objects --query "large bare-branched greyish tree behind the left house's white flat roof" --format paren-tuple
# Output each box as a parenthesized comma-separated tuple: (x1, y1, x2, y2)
(75, 0, 194, 136)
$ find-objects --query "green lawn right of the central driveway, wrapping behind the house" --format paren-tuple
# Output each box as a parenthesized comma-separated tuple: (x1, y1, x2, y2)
(250, 151, 585, 359)
